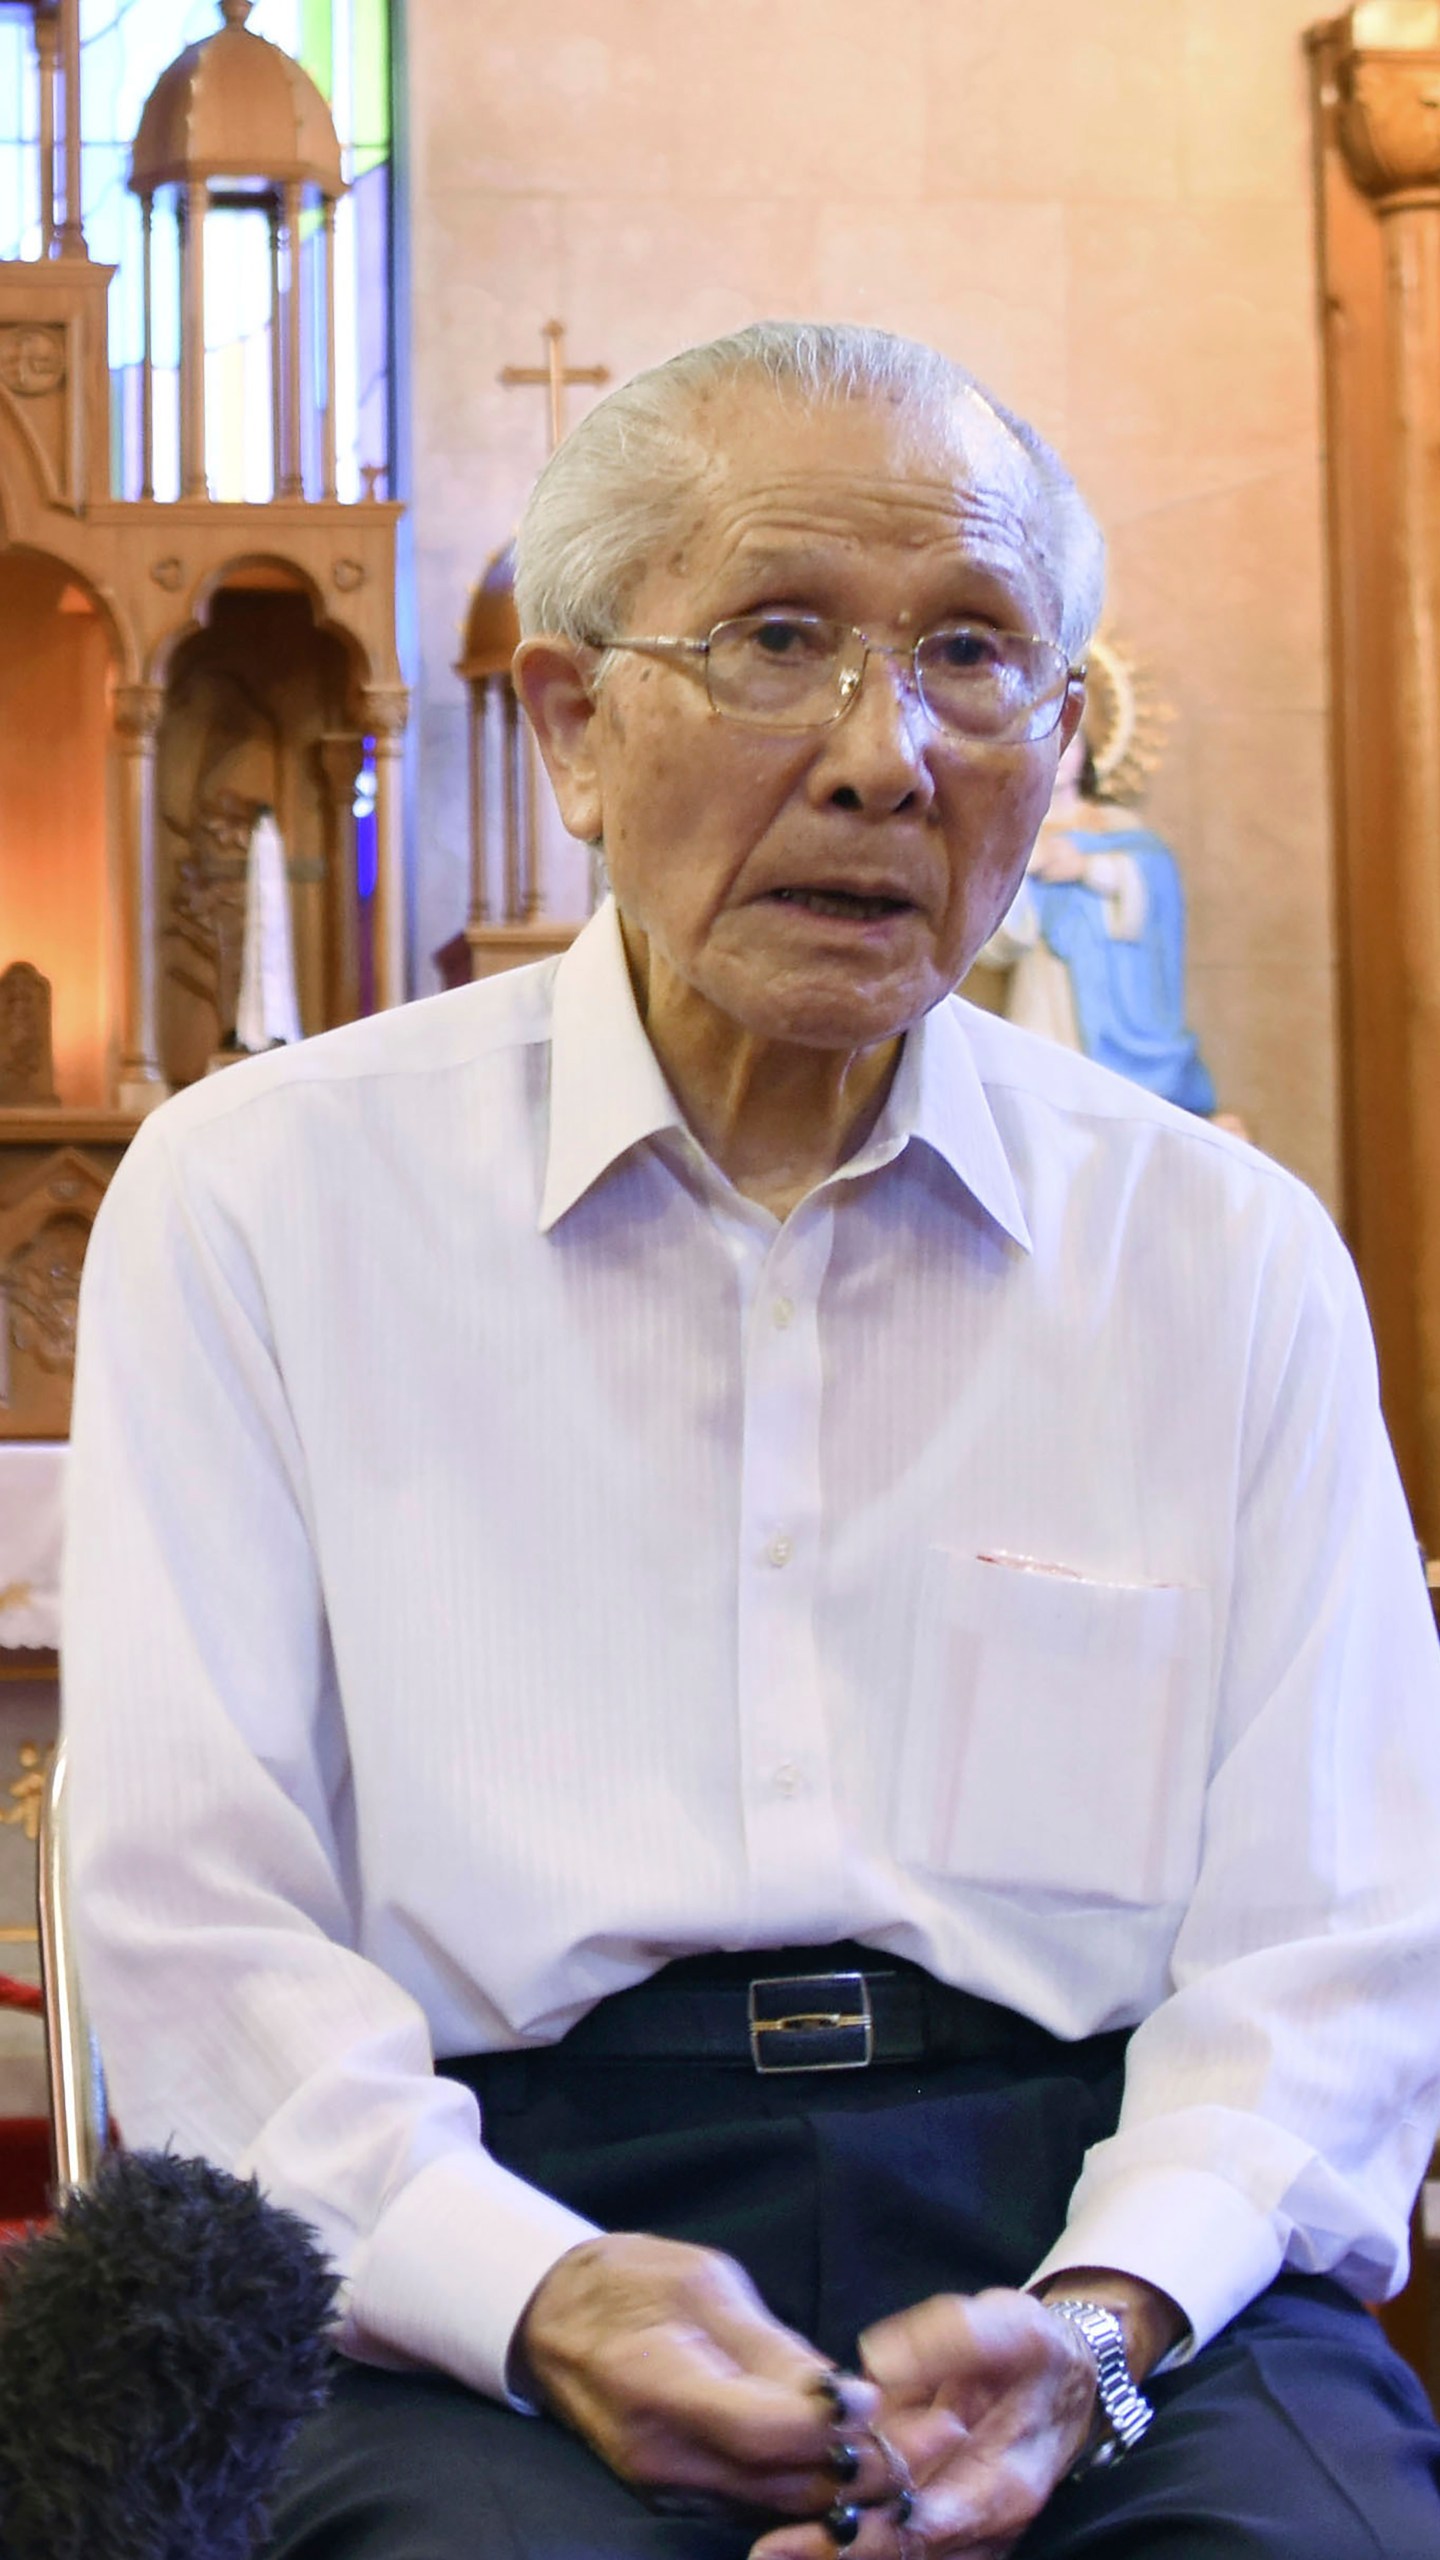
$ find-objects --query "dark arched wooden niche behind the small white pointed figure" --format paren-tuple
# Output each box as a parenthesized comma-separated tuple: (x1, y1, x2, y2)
(156, 561, 374, 1088)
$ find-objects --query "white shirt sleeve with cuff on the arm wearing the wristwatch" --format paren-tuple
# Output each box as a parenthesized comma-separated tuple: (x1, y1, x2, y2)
(1043, 1213, 1440, 2342)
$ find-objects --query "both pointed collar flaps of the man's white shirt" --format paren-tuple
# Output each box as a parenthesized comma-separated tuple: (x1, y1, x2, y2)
(541, 899, 1030, 1252)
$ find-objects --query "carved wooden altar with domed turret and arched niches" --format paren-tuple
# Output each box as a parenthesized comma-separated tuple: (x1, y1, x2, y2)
(0, 0, 407, 1439)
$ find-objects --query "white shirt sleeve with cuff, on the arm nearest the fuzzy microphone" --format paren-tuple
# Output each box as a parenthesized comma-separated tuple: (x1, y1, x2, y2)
(64, 1124, 587, 2394)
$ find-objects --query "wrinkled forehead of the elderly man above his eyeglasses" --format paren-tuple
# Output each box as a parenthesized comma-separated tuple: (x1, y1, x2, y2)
(656, 381, 1061, 620)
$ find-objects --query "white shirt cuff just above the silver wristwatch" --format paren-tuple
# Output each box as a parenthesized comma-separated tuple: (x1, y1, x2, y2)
(1030, 2168, 1284, 2368)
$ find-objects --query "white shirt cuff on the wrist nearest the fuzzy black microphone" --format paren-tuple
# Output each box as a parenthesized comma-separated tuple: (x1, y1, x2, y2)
(336, 2148, 594, 2409)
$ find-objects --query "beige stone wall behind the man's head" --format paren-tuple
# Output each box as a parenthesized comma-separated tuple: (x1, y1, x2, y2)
(407, 0, 1335, 1201)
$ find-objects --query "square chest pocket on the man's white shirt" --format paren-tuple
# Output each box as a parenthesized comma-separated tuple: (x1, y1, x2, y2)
(894, 1549, 1209, 1905)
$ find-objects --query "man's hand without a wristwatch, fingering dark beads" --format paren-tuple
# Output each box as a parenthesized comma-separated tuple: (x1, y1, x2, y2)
(515, 2232, 881, 2508)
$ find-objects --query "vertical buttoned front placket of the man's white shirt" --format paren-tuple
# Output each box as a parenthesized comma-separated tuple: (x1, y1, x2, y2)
(710, 1188, 840, 1940)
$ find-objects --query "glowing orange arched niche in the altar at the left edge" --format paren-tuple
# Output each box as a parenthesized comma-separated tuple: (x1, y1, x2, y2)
(0, 545, 115, 1111)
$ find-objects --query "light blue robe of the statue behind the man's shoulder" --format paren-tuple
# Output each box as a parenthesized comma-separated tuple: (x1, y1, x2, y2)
(1030, 827, 1215, 1114)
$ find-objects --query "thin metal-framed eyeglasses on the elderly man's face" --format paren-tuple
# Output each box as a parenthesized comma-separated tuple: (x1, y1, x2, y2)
(592, 612, 1084, 745)
